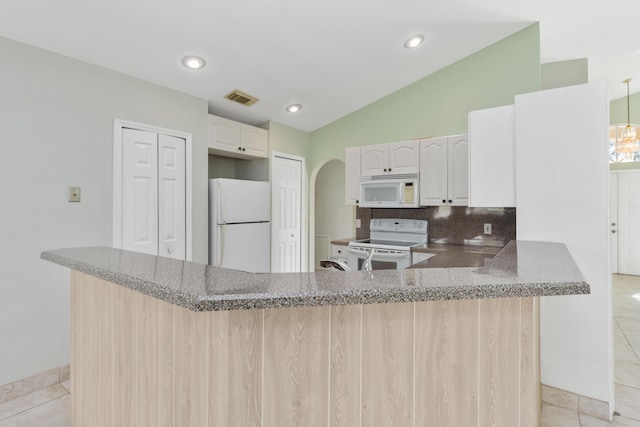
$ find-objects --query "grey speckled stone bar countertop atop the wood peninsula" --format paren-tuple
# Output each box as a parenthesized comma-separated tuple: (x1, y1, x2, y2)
(41, 241, 589, 311)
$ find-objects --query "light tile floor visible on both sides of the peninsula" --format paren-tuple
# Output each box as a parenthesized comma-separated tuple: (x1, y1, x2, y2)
(0, 275, 640, 427)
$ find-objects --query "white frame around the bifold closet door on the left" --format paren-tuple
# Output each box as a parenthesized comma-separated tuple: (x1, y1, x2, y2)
(113, 119, 193, 261)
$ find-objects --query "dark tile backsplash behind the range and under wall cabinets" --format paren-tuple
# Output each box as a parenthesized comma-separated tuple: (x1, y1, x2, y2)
(356, 206, 516, 246)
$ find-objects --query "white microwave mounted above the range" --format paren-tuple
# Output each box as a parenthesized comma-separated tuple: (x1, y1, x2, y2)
(359, 177, 420, 208)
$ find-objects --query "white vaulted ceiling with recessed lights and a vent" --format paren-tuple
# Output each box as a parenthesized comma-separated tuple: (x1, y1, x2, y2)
(0, 0, 640, 131)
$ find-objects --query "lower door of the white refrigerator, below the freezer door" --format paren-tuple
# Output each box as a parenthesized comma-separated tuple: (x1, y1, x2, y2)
(213, 222, 271, 273)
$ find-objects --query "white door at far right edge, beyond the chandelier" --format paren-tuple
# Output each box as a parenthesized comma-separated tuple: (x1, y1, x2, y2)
(617, 173, 640, 275)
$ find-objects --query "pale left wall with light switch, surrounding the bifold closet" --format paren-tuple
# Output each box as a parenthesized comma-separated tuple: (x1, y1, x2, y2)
(0, 38, 207, 384)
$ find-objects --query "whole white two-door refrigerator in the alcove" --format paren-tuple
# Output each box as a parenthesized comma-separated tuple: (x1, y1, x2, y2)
(209, 178, 271, 273)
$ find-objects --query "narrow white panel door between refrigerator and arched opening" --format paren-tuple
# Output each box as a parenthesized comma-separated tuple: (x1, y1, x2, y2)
(271, 156, 302, 273)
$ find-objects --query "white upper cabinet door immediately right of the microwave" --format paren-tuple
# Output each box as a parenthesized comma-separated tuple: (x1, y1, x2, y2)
(420, 136, 447, 206)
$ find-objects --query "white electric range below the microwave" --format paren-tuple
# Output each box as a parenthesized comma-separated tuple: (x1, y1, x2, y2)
(348, 218, 429, 270)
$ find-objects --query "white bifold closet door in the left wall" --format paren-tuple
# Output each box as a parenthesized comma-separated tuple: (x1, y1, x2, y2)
(122, 129, 186, 259)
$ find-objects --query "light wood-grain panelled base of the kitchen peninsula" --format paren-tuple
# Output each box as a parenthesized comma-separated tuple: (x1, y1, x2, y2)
(71, 271, 540, 427)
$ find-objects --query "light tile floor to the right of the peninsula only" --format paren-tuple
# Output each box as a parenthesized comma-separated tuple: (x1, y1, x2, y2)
(542, 274, 640, 427)
